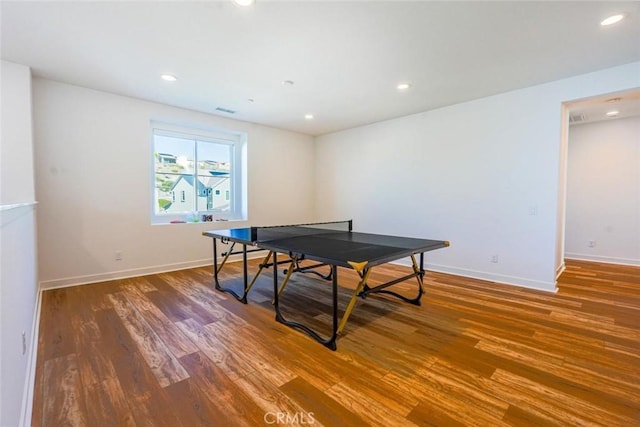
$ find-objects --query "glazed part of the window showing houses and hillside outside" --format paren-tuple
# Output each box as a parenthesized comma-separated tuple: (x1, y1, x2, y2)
(153, 124, 242, 222)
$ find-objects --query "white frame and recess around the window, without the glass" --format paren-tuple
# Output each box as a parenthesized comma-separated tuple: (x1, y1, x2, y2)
(150, 120, 247, 224)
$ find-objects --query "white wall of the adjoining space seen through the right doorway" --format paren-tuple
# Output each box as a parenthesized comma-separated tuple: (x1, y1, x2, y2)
(565, 117, 640, 265)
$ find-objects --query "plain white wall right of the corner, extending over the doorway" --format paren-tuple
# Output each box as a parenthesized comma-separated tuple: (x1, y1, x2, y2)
(316, 62, 640, 290)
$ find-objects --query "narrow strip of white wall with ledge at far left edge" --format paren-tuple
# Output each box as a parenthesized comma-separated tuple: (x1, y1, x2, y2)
(0, 61, 38, 426)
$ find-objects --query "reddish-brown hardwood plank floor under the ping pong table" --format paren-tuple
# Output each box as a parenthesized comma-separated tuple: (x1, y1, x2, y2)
(32, 261, 640, 427)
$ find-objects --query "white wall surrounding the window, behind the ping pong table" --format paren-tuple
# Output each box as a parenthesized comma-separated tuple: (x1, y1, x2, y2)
(33, 79, 314, 287)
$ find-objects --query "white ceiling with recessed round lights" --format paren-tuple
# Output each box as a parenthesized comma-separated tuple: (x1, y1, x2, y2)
(1, 0, 640, 135)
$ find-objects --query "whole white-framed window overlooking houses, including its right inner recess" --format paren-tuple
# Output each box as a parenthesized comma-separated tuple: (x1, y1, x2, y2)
(152, 122, 246, 223)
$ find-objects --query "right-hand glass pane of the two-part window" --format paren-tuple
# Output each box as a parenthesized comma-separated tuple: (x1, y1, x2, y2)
(197, 141, 232, 211)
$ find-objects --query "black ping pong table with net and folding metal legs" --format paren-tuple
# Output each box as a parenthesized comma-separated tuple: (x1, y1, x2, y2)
(202, 220, 449, 350)
